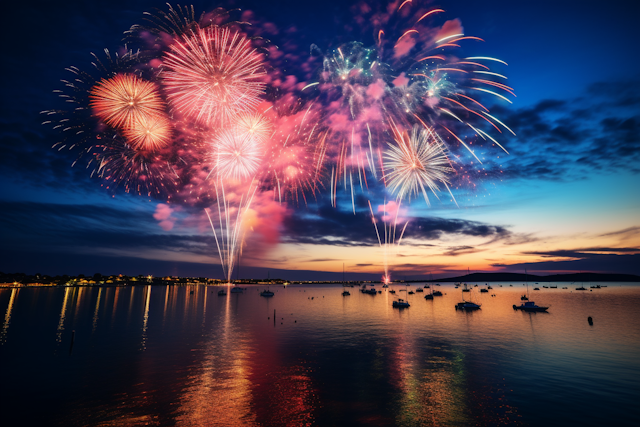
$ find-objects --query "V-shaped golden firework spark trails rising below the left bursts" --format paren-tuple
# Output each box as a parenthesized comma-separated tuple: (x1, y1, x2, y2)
(204, 181, 257, 283)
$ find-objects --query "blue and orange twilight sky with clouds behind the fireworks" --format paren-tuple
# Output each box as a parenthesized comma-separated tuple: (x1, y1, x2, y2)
(0, 0, 640, 280)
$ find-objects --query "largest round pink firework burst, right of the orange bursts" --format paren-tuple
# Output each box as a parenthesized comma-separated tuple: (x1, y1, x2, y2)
(161, 26, 266, 127)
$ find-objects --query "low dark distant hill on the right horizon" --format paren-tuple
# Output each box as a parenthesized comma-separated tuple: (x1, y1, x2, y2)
(428, 273, 640, 283)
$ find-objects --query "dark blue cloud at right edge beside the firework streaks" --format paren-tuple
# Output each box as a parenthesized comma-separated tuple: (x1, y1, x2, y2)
(485, 80, 640, 180)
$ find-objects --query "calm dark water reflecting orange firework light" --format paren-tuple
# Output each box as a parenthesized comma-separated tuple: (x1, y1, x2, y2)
(0, 283, 640, 426)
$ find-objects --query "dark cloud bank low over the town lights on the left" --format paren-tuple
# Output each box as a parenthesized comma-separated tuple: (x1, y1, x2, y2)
(0, 202, 215, 260)
